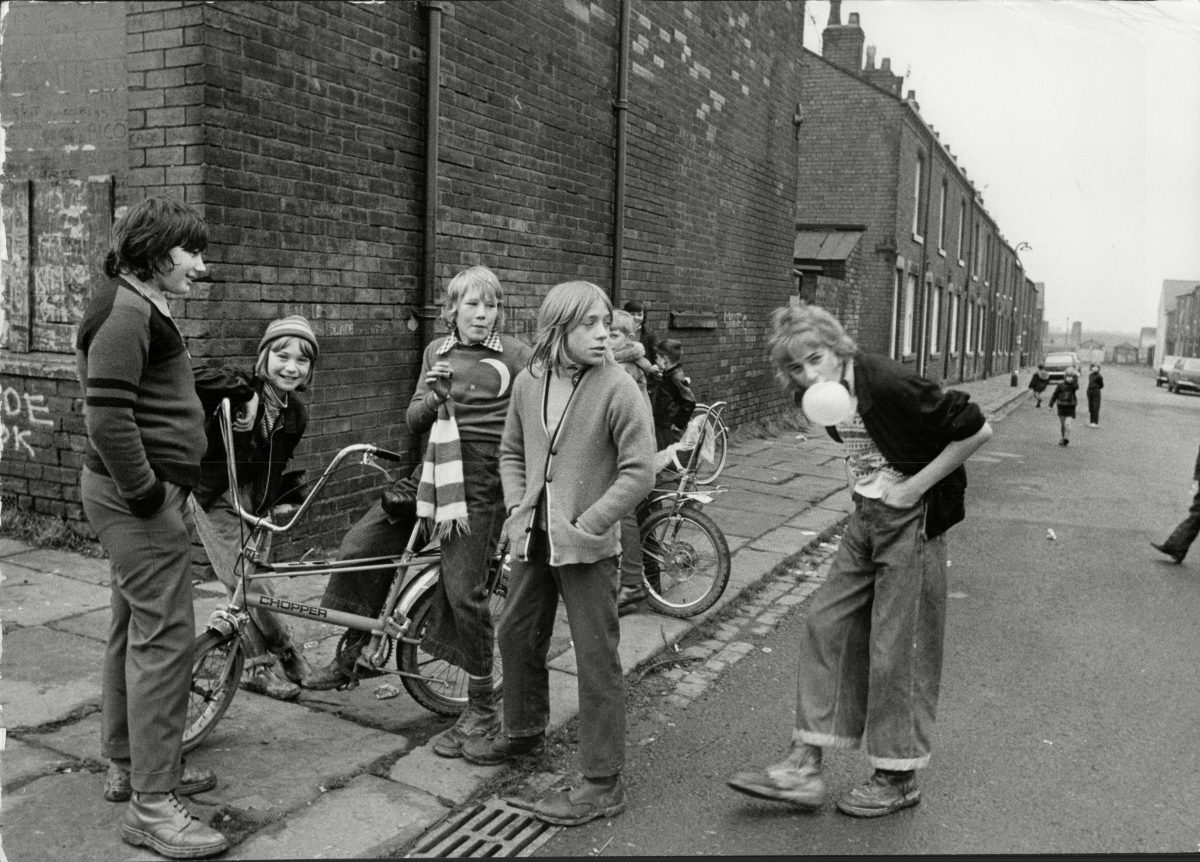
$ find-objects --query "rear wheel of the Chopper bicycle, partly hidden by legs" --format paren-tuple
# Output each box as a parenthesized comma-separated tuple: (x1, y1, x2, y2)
(396, 566, 508, 716)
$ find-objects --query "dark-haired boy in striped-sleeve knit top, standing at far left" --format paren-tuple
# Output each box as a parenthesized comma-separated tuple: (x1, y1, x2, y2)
(76, 197, 229, 858)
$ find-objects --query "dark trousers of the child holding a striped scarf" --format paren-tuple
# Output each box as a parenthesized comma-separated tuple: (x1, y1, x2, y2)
(420, 441, 504, 676)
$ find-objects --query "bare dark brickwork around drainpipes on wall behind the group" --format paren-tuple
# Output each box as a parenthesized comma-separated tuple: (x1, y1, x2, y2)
(0, 0, 803, 553)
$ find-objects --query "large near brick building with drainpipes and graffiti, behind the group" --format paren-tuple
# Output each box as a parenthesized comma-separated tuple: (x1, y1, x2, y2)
(0, 0, 804, 543)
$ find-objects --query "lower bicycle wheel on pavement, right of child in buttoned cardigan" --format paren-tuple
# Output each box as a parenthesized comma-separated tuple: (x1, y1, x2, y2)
(641, 508, 730, 618)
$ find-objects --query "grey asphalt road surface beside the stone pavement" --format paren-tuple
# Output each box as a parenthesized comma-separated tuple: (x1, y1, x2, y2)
(538, 366, 1200, 856)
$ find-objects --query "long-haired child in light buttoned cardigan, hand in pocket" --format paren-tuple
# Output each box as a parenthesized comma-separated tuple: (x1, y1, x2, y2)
(463, 281, 654, 826)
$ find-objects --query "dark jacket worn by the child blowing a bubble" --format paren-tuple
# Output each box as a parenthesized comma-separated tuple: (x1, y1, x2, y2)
(826, 352, 986, 539)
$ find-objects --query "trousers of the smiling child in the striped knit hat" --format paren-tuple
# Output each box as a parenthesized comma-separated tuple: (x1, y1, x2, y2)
(187, 487, 292, 668)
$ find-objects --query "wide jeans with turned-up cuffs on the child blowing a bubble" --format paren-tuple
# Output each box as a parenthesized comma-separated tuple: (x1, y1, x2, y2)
(794, 495, 946, 770)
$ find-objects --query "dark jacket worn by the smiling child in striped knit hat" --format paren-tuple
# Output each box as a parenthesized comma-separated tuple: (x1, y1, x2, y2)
(192, 365, 308, 515)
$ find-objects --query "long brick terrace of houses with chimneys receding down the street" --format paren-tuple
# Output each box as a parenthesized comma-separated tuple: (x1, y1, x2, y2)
(794, 2, 1040, 383)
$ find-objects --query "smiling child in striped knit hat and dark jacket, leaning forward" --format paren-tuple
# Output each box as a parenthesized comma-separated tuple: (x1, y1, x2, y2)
(192, 315, 319, 700)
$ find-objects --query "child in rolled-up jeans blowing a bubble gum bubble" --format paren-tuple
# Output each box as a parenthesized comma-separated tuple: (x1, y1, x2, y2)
(728, 306, 991, 818)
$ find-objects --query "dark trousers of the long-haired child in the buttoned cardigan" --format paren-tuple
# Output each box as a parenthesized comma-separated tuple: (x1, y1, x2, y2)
(499, 529, 625, 778)
